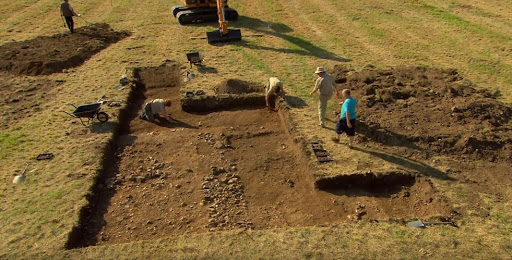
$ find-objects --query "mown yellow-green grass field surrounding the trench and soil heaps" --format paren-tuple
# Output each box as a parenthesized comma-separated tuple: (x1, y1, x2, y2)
(0, 0, 512, 259)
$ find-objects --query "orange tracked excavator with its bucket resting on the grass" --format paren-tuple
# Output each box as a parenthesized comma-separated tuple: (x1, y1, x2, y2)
(172, 0, 242, 44)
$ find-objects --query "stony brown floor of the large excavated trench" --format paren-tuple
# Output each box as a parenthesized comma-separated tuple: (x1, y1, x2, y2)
(76, 66, 452, 246)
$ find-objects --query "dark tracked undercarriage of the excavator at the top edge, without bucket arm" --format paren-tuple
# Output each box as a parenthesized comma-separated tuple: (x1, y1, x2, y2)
(172, 0, 238, 25)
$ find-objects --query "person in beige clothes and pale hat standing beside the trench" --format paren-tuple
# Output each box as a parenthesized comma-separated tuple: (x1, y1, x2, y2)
(310, 67, 337, 127)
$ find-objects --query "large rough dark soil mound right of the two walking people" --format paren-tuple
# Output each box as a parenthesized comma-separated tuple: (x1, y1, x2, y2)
(333, 66, 512, 161)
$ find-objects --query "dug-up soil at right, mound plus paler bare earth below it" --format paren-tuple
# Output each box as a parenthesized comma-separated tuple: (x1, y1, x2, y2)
(333, 66, 512, 217)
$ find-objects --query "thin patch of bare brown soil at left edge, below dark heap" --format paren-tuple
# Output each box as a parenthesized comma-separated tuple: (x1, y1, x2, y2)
(0, 72, 61, 129)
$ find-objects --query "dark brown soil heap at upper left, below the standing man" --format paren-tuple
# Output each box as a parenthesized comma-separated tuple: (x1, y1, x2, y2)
(0, 23, 130, 75)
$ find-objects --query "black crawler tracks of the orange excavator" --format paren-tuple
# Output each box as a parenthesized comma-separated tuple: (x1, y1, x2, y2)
(172, 6, 238, 25)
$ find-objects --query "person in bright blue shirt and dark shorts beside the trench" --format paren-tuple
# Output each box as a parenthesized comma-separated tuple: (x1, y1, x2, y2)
(332, 89, 357, 147)
